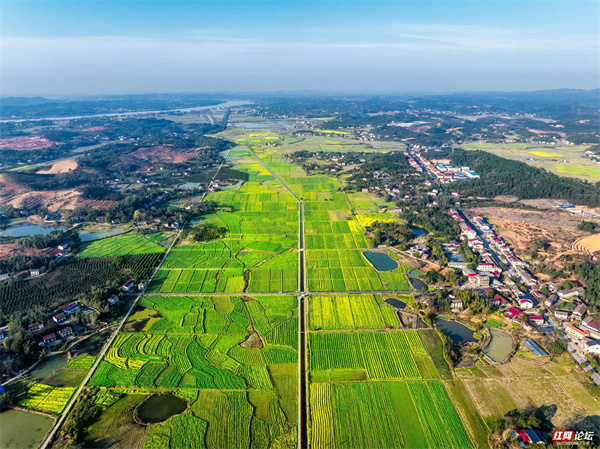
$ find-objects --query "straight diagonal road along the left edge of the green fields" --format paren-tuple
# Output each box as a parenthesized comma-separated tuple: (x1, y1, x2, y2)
(38, 151, 229, 449)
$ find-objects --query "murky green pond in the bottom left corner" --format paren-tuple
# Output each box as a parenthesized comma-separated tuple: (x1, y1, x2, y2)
(0, 410, 54, 449)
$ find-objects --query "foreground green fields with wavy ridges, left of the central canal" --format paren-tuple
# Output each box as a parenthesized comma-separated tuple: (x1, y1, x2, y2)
(86, 296, 298, 448)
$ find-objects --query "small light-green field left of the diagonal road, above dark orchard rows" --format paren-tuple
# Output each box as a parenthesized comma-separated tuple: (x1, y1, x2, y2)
(77, 234, 165, 258)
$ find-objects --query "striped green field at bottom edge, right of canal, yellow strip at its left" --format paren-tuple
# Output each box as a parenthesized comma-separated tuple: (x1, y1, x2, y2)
(310, 381, 473, 449)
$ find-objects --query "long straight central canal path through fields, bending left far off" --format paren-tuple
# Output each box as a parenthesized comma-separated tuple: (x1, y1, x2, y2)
(246, 146, 309, 449)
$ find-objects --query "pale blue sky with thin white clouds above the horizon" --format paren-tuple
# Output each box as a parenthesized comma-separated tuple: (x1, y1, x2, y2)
(0, 0, 599, 96)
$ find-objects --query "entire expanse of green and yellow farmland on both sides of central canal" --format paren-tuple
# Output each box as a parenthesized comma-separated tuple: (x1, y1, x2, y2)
(71, 129, 488, 449)
